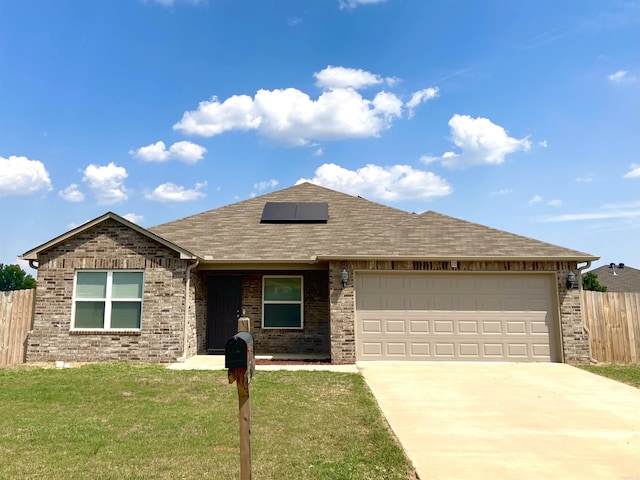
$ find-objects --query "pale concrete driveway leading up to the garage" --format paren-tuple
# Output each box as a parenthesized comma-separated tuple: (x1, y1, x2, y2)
(358, 362, 640, 480)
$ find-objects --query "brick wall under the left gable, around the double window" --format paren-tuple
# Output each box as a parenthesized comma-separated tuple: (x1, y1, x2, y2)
(27, 219, 195, 362)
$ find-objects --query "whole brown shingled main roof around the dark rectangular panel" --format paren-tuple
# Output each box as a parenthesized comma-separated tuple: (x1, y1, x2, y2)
(149, 183, 597, 262)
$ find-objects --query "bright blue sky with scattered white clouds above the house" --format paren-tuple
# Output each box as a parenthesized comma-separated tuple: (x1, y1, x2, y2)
(0, 0, 640, 274)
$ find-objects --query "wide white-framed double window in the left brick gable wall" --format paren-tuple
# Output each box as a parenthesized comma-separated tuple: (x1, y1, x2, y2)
(73, 270, 143, 330)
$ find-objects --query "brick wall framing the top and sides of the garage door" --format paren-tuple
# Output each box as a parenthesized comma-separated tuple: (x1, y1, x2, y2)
(329, 260, 591, 364)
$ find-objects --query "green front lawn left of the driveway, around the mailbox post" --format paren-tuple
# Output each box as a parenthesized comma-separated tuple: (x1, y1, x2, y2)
(0, 364, 415, 480)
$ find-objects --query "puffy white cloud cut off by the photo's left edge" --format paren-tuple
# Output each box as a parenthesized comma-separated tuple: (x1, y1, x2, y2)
(0, 155, 52, 197)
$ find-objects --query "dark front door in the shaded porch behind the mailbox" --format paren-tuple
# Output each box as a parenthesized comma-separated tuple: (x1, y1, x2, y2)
(207, 275, 242, 351)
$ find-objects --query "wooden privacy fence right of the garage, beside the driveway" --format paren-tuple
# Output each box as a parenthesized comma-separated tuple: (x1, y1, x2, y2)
(582, 290, 640, 363)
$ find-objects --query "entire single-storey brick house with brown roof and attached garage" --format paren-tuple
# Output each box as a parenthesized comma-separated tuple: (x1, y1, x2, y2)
(22, 183, 597, 364)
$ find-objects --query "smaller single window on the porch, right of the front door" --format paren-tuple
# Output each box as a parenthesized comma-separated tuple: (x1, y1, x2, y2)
(262, 276, 303, 328)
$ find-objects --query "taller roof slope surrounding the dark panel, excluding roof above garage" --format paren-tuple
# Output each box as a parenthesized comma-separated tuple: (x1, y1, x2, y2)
(150, 183, 412, 262)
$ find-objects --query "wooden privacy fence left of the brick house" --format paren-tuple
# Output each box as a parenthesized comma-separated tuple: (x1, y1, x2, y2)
(0, 288, 36, 365)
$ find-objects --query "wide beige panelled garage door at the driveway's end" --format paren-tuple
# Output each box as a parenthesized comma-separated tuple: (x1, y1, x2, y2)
(355, 272, 559, 362)
